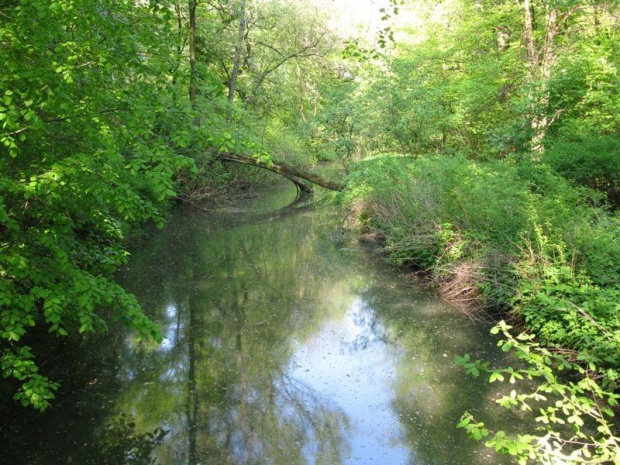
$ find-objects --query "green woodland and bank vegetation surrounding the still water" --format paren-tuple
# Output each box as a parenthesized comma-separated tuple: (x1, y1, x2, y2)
(0, 0, 620, 463)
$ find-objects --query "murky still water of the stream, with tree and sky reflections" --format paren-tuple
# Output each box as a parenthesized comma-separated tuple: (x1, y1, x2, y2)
(2, 184, 516, 465)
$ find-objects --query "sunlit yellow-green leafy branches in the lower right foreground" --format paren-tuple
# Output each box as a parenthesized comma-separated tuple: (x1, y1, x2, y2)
(456, 321, 620, 464)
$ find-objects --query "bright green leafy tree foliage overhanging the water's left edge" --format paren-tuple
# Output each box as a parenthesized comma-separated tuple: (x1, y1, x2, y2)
(0, 0, 194, 409)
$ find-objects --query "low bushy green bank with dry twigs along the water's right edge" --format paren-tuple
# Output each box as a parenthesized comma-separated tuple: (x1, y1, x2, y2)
(343, 155, 620, 460)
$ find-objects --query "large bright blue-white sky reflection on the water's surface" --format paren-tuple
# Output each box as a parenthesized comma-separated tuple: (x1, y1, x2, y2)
(290, 298, 410, 465)
